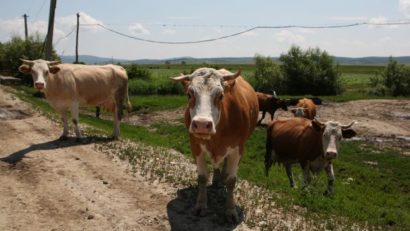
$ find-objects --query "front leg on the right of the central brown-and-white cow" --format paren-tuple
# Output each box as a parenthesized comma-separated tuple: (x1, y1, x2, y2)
(225, 147, 243, 223)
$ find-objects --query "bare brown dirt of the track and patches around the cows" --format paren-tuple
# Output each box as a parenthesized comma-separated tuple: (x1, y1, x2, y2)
(0, 86, 410, 230)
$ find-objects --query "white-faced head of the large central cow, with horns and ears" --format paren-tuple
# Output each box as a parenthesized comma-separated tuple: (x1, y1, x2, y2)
(172, 68, 240, 139)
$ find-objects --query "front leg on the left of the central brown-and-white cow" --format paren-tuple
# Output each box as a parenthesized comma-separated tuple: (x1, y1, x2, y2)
(195, 153, 208, 216)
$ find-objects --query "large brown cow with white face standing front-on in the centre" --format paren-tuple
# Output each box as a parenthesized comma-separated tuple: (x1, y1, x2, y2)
(172, 68, 259, 222)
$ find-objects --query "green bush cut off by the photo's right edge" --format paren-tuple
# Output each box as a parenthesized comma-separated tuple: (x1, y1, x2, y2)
(382, 57, 410, 96)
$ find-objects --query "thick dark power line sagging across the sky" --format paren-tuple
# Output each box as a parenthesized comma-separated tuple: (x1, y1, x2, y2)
(81, 21, 410, 45)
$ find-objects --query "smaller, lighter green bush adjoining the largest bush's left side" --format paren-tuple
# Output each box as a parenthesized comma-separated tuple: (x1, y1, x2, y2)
(252, 55, 284, 94)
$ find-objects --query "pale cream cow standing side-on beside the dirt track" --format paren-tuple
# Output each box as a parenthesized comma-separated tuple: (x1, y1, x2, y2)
(19, 59, 131, 140)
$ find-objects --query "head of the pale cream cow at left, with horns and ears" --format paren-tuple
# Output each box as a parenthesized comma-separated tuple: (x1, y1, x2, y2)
(19, 59, 60, 91)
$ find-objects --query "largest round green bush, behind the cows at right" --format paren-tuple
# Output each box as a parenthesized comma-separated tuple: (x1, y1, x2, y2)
(279, 46, 342, 95)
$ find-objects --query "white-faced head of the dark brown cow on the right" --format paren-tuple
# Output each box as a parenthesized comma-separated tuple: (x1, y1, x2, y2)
(312, 119, 356, 160)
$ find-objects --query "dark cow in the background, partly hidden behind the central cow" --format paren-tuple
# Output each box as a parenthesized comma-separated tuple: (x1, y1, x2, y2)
(256, 92, 288, 124)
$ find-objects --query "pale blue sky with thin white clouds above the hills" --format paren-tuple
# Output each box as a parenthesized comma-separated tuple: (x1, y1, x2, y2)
(0, 0, 410, 59)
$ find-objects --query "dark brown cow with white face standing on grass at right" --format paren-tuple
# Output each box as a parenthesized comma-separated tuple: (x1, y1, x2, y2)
(265, 117, 356, 195)
